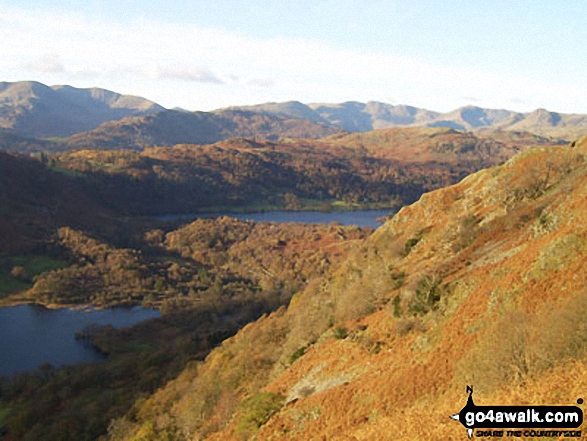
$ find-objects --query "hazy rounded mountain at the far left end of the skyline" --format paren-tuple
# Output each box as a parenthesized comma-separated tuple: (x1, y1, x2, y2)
(0, 81, 163, 138)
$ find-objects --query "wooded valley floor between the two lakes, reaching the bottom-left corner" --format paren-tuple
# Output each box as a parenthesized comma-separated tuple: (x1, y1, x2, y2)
(0, 217, 372, 441)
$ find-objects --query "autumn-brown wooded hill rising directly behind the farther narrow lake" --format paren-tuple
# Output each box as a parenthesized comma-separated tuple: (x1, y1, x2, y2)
(51, 127, 553, 214)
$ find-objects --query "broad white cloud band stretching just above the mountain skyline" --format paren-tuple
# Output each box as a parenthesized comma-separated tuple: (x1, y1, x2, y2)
(0, 6, 587, 111)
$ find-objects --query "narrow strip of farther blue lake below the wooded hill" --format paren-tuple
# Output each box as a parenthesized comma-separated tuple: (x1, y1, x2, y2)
(156, 209, 396, 228)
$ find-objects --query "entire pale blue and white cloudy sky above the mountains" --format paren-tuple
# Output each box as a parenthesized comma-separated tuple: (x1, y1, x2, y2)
(0, 0, 587, 113)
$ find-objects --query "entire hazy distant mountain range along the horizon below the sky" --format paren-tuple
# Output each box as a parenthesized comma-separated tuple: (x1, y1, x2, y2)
(0, 81, 587, 151)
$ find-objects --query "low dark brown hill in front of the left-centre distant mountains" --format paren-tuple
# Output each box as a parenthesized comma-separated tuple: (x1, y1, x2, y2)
(66, 110, 340, 150)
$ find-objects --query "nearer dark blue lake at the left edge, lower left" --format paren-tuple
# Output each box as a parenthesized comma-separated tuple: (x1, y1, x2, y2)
(0, 305, 161, 377)
